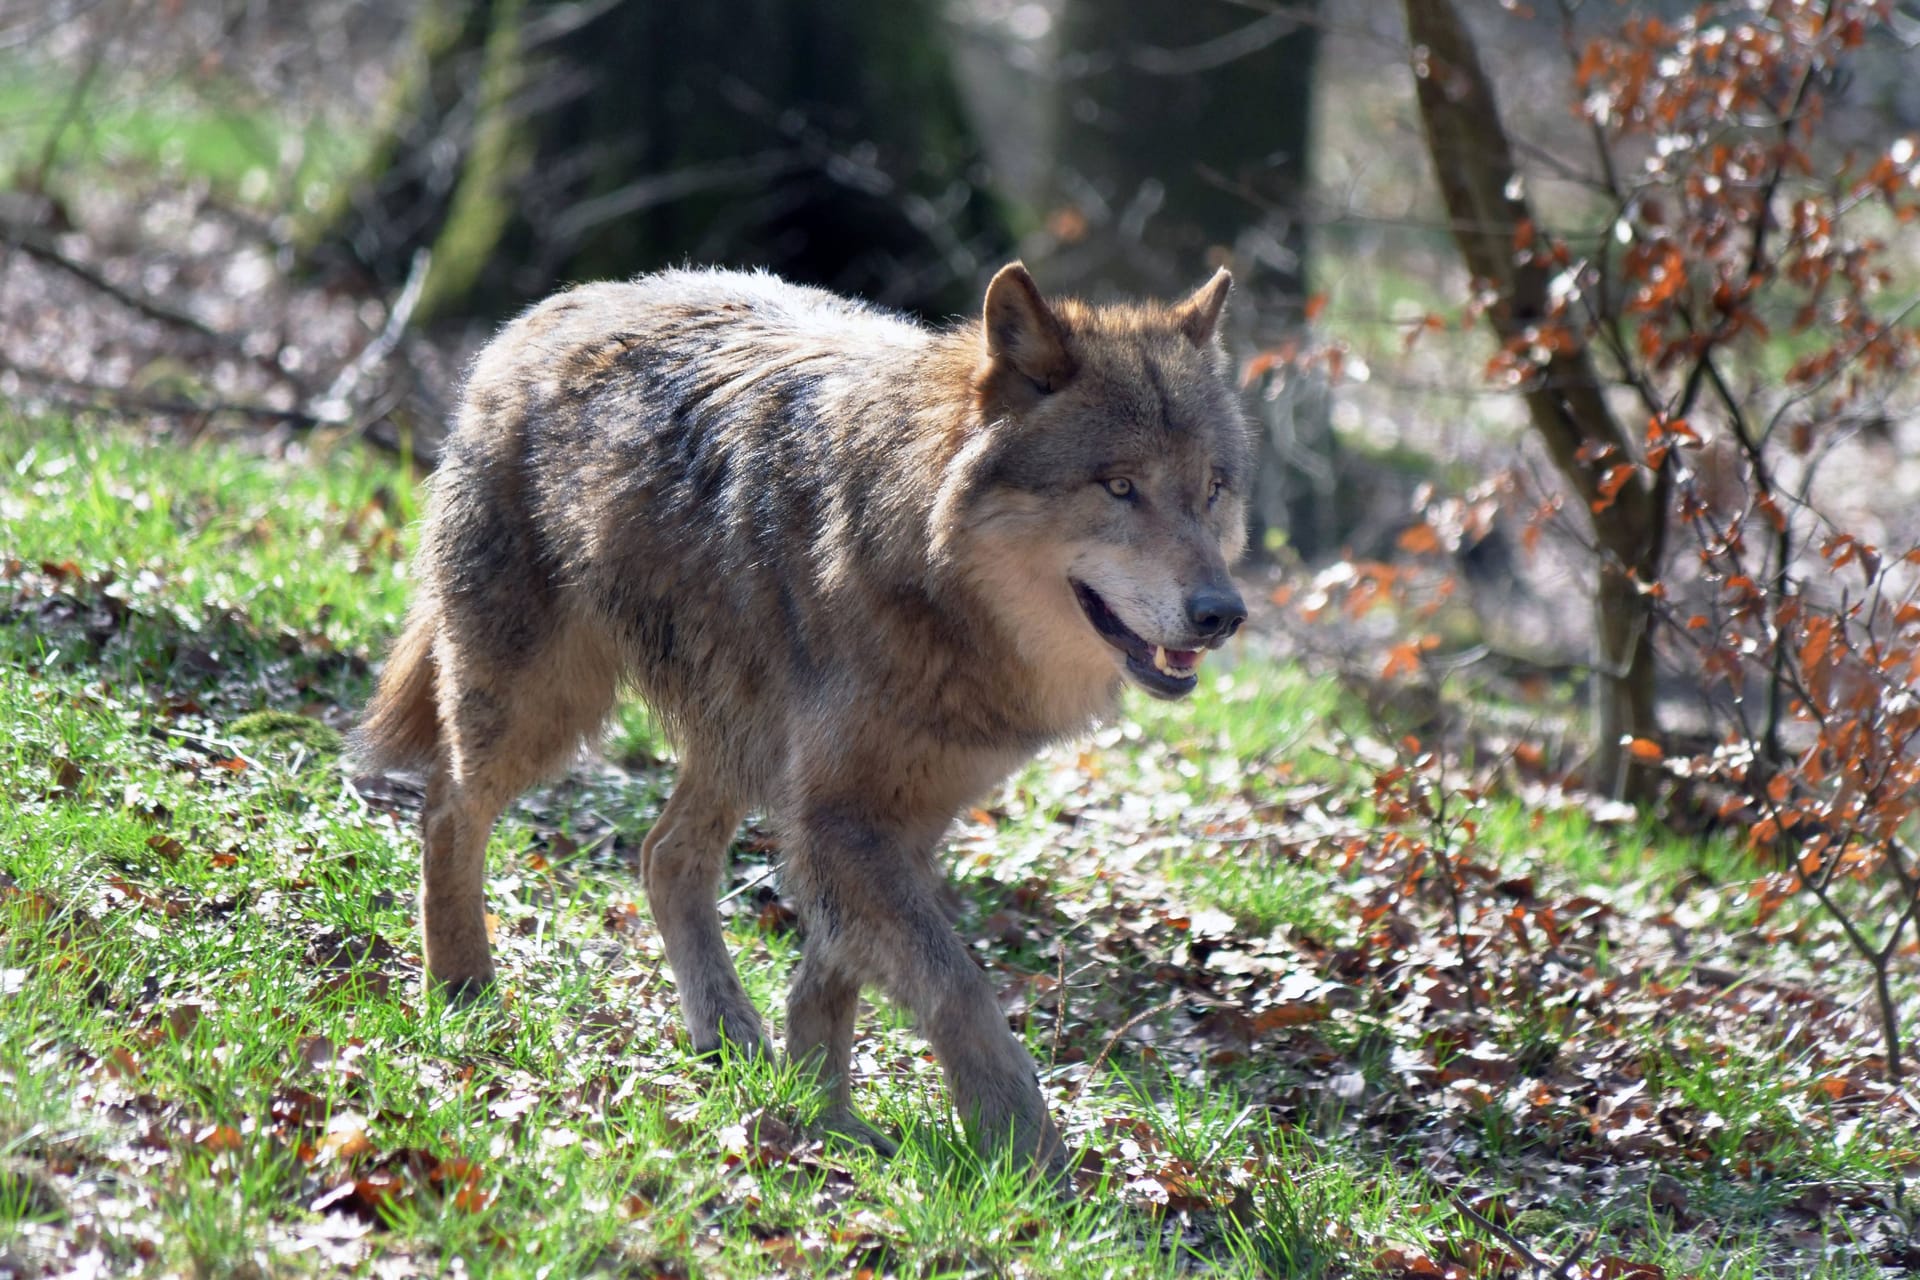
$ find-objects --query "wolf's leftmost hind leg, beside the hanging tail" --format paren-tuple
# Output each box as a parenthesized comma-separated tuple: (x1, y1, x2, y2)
(420, 624, 616, 996)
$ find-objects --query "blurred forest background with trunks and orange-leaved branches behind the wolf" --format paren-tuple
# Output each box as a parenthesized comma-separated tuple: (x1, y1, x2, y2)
(11, 0, 1920, 852)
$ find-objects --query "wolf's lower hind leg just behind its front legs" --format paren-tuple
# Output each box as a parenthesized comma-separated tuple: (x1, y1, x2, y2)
(639, 767, 766, 1054)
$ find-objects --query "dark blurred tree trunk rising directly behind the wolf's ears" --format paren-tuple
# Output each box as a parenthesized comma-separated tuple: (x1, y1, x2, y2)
(1048, 0, 1331, 553)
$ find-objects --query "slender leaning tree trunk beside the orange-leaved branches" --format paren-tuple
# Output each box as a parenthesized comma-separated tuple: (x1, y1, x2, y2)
(1405, 0, 1667, 800)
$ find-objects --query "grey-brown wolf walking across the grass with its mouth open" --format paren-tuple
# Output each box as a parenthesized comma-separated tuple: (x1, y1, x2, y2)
(357, 263, 1252, 1171)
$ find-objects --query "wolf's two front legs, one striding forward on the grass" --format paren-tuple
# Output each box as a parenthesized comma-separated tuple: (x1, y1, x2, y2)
(785, 806, 1066, 1171)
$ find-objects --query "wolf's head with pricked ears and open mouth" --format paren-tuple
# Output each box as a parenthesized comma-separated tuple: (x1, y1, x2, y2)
(941, 263, 1252, 699)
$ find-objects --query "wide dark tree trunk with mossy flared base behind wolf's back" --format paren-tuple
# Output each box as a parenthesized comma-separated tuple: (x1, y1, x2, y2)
(305, 0, 1006, 319)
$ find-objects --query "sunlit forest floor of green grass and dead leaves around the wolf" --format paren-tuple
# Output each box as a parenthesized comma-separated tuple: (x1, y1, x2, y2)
(0, 418, 1920, 1280)
